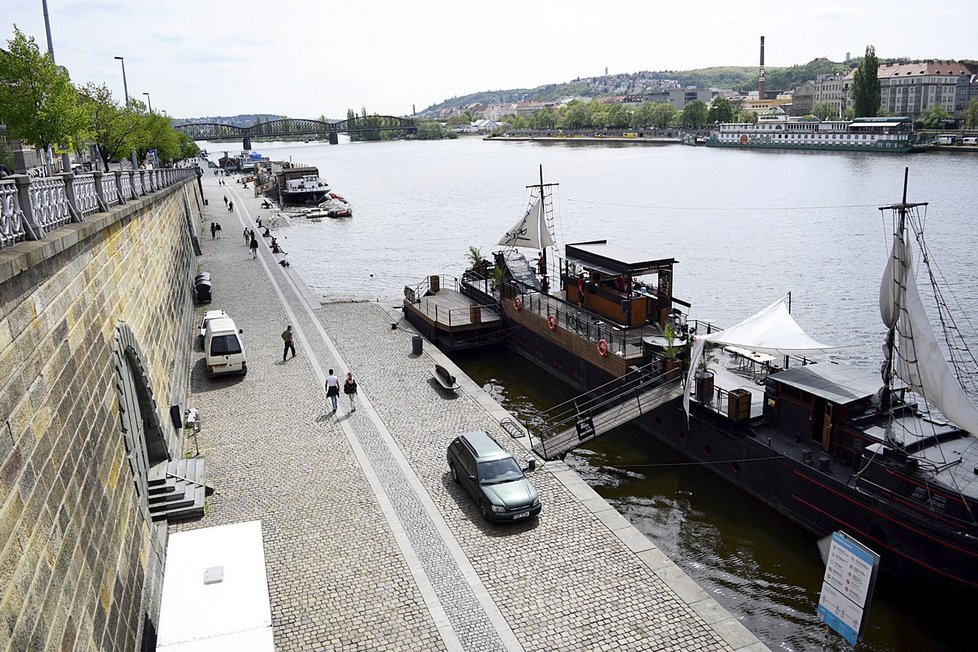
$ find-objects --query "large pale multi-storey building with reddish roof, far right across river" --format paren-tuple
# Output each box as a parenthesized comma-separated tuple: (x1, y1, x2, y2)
(872, 61, 973, 118)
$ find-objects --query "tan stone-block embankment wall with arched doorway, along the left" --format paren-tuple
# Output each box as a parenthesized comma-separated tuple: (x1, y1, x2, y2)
(0, 178, 202, 651)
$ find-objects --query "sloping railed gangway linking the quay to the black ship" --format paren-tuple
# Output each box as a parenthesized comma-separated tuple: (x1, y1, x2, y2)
(531, 363, 683, 460)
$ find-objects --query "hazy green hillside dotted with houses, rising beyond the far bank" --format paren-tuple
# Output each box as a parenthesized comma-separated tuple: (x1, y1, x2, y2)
(422, 58, 857, 113)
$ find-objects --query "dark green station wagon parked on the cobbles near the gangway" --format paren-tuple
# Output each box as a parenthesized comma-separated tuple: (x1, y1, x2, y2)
(446, 432, 542, 521)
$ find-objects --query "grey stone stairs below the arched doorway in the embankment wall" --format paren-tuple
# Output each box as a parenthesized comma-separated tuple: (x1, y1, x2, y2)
(147, 457, 214, 521)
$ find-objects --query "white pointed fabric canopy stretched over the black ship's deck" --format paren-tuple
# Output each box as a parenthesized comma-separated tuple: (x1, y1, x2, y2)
(683, 297, 854, 414)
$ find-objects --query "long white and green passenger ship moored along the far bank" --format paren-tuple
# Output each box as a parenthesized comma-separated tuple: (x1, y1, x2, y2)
(705, 108, 920, 153)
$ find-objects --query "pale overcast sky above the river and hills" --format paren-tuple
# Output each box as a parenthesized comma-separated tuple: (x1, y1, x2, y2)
(0, 0, 978, 118)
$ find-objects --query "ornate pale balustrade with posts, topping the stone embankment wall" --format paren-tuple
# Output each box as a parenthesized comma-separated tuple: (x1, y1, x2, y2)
(0, 168, 198, 250)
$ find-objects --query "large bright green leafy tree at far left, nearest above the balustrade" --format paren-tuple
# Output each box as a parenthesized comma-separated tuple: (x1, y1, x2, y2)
(0, 25, 87, 163)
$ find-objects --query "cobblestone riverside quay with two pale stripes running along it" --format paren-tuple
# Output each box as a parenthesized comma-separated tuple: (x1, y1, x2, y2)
(177, 175, 767, 652)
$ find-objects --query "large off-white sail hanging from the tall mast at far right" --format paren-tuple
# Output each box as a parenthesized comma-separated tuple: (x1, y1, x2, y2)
(880, 234, 978, 437)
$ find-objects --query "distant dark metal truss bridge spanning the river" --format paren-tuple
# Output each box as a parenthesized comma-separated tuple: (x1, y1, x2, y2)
(175, 115, 418, 149)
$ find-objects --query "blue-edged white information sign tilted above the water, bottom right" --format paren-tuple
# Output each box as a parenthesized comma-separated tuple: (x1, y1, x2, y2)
(818, 532, 880, 645)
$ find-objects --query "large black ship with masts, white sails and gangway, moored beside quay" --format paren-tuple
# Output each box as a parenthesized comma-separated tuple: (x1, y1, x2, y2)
(438, 167, 978, 594)
